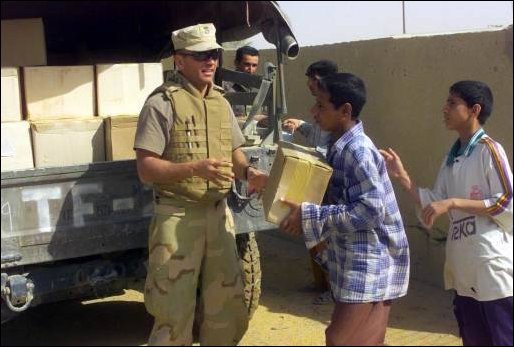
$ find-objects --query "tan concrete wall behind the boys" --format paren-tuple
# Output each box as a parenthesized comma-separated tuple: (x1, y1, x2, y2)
(228, 26, 513, 285)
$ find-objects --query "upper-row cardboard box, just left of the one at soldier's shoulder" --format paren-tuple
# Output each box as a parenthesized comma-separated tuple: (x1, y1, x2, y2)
(23, 66, 95, 121)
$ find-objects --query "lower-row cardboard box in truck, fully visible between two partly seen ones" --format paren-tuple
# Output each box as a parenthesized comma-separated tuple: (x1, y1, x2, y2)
(31, 118, 105, 168)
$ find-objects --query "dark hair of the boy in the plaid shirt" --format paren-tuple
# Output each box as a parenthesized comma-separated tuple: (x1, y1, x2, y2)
(319, 73, 366, 119)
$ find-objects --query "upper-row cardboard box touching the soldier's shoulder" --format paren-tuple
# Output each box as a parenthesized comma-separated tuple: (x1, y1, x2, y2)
(96, 63, 163, 117)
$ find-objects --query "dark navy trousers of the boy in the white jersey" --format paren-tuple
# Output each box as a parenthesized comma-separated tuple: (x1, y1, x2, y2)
(453, 294, 512, 346)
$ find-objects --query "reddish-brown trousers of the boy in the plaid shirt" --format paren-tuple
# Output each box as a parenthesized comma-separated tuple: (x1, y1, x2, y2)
(325, 300, 391, 346)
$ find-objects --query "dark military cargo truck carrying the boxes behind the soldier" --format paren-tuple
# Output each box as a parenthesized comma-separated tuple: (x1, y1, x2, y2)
(1, 1, 299, 323)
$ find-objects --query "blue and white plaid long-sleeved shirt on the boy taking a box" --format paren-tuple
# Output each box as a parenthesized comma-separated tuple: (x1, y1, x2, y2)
(302, 122, 409, 303)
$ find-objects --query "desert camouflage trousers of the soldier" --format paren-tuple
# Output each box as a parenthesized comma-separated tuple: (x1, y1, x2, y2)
(145, 200, 248, 346)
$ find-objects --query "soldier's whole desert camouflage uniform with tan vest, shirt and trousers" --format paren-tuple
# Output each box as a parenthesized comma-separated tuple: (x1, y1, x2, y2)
(134, 25, 248, 345)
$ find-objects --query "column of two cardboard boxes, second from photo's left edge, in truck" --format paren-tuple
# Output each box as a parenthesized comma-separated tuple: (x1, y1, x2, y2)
(23, 66, 105, 167)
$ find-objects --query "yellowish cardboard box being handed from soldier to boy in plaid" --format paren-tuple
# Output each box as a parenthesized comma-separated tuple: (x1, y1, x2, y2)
(262, 142, 332, 224)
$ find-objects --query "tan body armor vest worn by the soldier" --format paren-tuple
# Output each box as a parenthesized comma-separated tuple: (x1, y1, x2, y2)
(152, 82, 232, 203)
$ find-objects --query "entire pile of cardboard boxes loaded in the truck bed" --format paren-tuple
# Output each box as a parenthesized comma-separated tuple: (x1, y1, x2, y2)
(1, 19, 163, 171)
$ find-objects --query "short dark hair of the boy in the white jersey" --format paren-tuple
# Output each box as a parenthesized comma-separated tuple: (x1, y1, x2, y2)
(450, 81, 493, 125)
